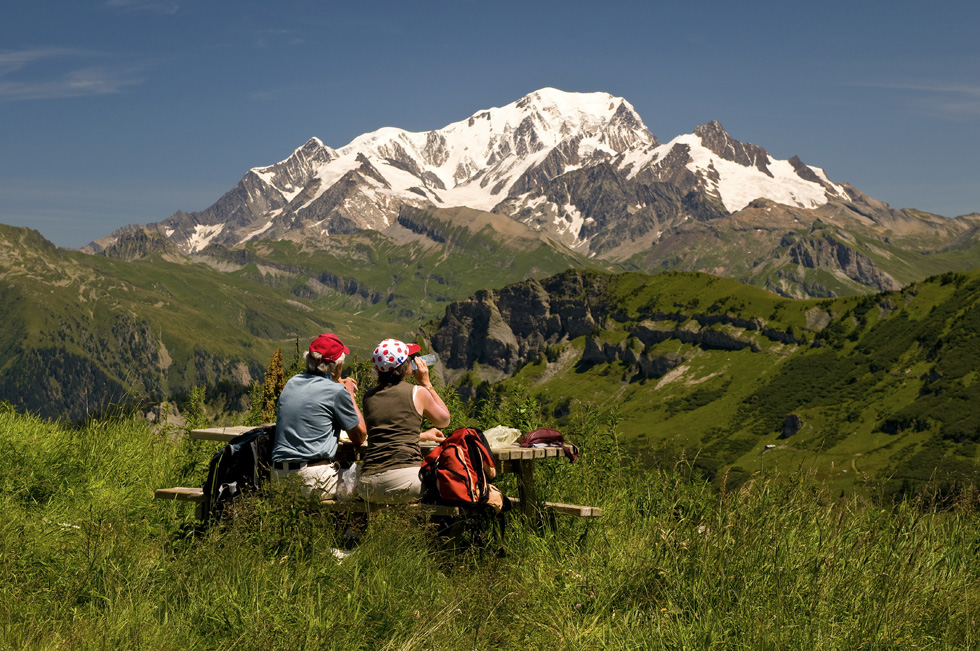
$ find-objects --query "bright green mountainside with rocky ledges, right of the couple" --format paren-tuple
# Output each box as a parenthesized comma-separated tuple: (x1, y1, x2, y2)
(426, 271, 980, 495)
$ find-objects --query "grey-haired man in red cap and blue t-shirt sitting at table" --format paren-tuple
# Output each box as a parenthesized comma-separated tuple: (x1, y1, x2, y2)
(272, 334, 367, 499)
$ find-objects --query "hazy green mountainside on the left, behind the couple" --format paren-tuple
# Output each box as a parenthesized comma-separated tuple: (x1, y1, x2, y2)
(0, 210, 585, 419)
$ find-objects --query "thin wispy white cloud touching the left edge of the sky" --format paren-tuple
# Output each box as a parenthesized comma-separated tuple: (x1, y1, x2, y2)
(0, 48, 143, 102)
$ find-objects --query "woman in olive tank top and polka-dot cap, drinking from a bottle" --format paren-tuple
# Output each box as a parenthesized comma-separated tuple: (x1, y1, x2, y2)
(357, 339, 450, 504)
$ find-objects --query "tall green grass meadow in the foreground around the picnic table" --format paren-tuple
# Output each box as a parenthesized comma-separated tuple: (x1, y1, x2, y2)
(0, 408, 980, 651)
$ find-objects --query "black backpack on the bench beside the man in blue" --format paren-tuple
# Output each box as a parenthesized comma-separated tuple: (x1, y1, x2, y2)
(203, 425, 276, 523)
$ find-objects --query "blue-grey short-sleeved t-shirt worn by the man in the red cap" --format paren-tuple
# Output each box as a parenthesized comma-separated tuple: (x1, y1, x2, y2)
(272, 373, 360, 461)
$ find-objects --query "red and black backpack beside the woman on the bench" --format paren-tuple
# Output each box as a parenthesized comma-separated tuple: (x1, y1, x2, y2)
(419, 427, 497, 506)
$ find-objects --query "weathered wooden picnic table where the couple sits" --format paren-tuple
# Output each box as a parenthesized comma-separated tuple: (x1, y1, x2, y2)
(190, 425, 602, 518)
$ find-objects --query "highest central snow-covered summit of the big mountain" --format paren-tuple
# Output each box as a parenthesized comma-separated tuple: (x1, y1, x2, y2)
(324, 88, 656, 210)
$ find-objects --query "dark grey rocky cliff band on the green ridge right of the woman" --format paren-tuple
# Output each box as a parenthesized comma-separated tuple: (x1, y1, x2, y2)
(421, 271, 804, 382)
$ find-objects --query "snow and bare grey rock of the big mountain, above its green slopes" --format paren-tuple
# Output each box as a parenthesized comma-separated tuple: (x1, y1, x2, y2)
(92, 88, 859, 257)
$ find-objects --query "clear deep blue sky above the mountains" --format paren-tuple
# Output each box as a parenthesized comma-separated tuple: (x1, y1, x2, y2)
(0, 0, 980, 247)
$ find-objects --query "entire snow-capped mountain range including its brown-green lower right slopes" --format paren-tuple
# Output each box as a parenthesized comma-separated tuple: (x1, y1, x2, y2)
(84, 88, 980, 298)
